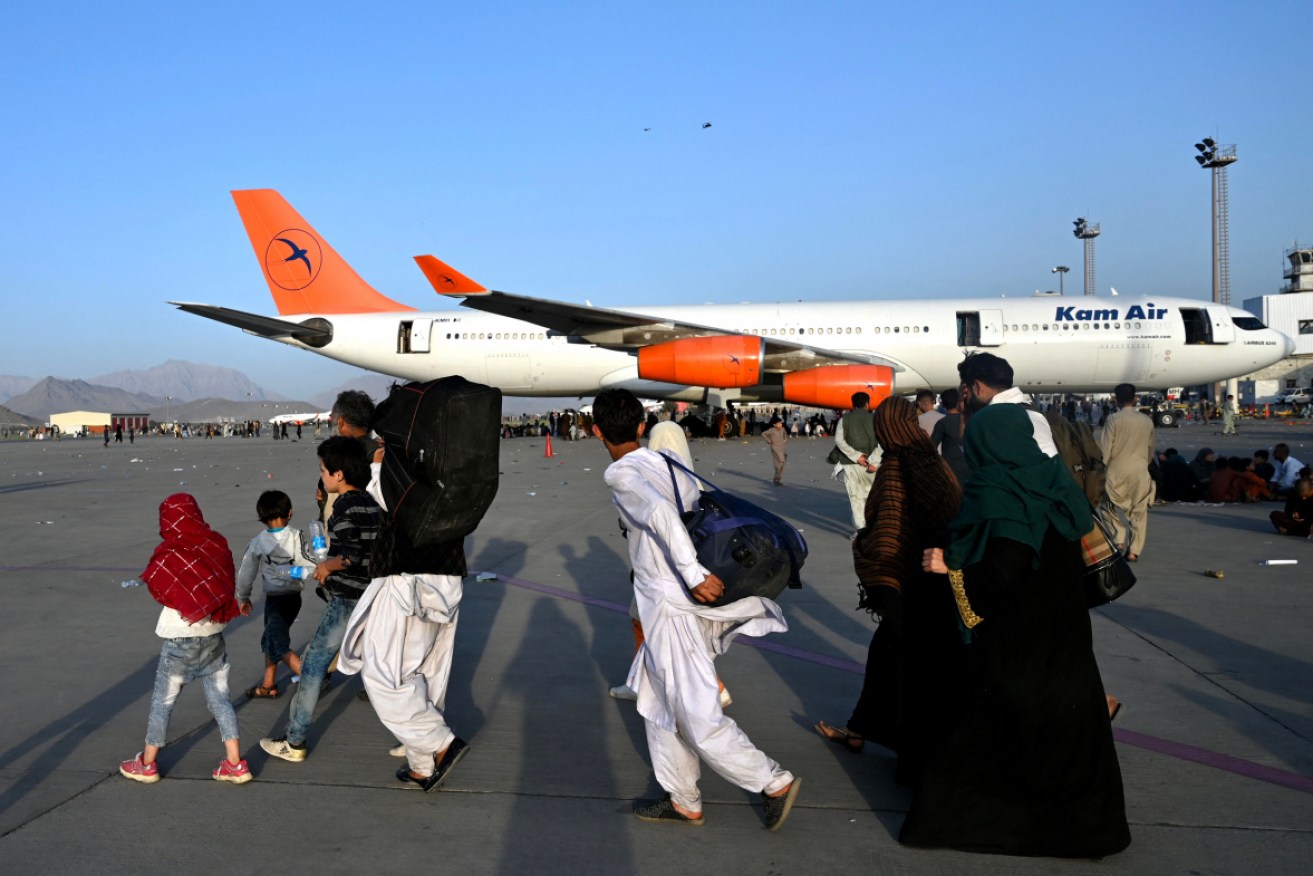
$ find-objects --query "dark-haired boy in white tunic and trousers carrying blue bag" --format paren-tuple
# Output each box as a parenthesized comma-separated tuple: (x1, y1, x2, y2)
(592, 389, 801, 830)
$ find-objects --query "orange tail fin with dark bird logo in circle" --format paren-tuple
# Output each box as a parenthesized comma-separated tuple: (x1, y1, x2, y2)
(232, 189, 414, 315)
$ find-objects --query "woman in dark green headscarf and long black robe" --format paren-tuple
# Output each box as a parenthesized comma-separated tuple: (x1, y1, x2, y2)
(899, 405, 1130, 858)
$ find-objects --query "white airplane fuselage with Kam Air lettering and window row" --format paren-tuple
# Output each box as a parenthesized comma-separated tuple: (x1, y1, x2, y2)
(258, 296, 1293, 401)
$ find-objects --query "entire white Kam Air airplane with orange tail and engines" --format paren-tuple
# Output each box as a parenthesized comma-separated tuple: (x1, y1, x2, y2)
(169, 189, 1295, 408)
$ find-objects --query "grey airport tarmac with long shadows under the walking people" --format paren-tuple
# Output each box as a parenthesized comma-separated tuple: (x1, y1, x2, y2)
(0, 422, 1313, 873)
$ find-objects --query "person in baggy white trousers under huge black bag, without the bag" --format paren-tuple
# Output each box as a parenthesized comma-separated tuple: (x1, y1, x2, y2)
(337, 441, 469, 791)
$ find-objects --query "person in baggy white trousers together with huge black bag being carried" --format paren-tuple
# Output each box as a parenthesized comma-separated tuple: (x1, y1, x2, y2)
(337, 377, 502, 791)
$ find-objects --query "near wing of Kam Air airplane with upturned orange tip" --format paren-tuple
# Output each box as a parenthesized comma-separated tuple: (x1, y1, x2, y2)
(415, 256, 903, 372)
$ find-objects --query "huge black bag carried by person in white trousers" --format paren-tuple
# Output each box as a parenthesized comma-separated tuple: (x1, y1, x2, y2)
(373, 377, 502, 548)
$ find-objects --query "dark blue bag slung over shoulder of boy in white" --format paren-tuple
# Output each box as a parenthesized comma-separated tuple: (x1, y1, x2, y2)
(662, 453, 807, 605)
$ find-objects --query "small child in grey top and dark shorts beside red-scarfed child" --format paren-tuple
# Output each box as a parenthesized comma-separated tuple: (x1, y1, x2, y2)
(238, 490, 314, 700)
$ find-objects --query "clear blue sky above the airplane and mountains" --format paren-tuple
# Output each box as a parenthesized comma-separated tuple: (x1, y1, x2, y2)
(0, 1, 1313, 397)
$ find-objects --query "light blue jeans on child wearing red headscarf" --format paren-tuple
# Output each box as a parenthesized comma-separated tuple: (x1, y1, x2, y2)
(146, 633, 240, 747)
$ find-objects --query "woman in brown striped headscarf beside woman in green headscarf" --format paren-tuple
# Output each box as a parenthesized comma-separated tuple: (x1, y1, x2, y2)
(815, 397, 962, 784)
